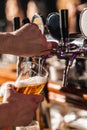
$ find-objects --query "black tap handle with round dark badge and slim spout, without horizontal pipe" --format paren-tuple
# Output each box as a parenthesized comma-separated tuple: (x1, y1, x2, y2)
(47, 10, 71, 87)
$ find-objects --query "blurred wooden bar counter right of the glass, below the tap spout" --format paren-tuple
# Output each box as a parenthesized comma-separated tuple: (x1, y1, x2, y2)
(48, 81, 87, 110)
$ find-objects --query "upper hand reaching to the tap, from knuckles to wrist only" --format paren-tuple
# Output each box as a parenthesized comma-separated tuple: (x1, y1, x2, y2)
(10, 24, 57, 56)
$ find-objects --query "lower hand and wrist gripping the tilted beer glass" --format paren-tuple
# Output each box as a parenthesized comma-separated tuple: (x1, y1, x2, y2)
(0, 85, 43, 129)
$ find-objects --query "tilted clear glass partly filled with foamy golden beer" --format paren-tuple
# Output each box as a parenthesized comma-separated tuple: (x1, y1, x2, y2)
(15, 62, 48, 94)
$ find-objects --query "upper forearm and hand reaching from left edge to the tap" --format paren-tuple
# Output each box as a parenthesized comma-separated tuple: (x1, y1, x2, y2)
(0, 24, 52, 56)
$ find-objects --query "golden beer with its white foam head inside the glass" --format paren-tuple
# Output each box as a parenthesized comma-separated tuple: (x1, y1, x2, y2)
(15, 76, 46, 94)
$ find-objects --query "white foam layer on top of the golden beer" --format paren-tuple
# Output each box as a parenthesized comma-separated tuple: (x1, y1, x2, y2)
(15, 76, 47, 88)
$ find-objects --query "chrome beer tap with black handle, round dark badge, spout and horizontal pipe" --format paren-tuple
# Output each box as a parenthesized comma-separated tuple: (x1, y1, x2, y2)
(47, 10, 87, 87)
